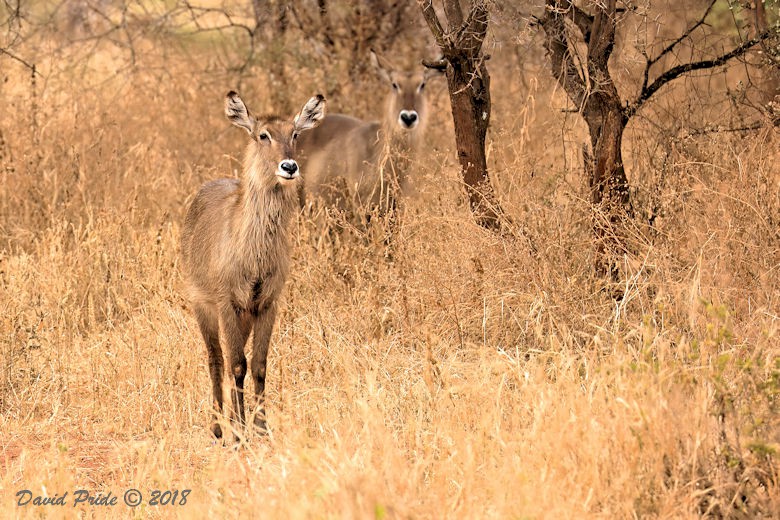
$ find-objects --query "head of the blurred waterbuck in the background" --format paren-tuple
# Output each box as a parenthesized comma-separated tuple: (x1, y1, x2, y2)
(371, 51, 440, 132)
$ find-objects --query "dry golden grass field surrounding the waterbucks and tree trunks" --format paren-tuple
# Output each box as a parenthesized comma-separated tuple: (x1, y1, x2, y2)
(0, 3, 780, 519)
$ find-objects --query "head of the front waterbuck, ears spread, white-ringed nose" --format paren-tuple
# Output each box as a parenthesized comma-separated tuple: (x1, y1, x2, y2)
(225, 91, 325, 186)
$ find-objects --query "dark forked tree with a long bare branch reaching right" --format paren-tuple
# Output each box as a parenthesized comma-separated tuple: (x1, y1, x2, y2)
(537, 0, 777, 280)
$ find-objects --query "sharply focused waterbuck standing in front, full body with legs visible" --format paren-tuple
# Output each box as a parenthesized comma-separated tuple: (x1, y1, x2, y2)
(182, 91, 325, 438)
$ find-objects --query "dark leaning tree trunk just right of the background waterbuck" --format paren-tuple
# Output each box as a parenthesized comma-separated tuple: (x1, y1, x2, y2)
(418, 0, 502, 231)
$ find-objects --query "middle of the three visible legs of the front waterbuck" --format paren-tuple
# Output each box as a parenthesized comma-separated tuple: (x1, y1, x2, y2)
(220, 305, 251, 441)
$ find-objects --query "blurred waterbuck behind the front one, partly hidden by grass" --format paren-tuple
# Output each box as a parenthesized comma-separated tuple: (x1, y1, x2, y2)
(299, 51, 439, 213)
